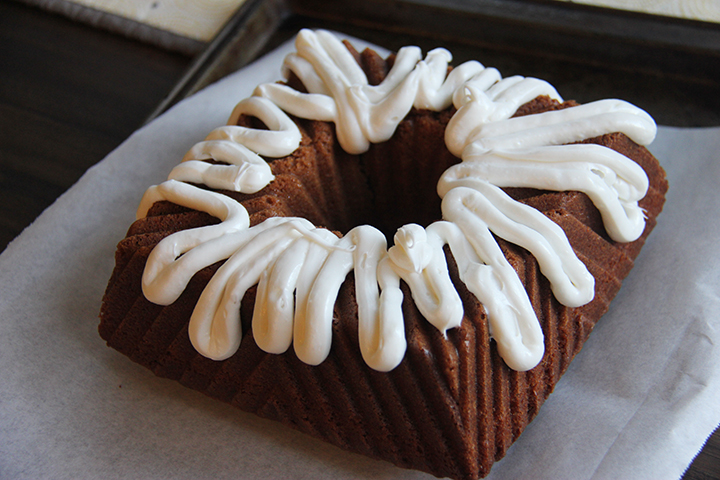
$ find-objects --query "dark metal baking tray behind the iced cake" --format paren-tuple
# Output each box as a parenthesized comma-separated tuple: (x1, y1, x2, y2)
(148, 0, 720, 126)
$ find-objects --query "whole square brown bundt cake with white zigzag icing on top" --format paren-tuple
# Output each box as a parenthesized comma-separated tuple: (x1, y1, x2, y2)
(99, 30, 667, 479)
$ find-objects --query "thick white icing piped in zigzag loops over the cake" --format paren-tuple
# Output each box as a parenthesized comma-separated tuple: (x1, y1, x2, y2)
(138, 30, 656, 371)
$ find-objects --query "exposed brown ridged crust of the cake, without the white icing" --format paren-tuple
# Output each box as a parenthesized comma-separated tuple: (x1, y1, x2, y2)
(99, 45, 667, 479)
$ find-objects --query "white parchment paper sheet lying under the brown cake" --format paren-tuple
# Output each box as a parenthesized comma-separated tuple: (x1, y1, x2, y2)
(0, 34, 720, 480)
